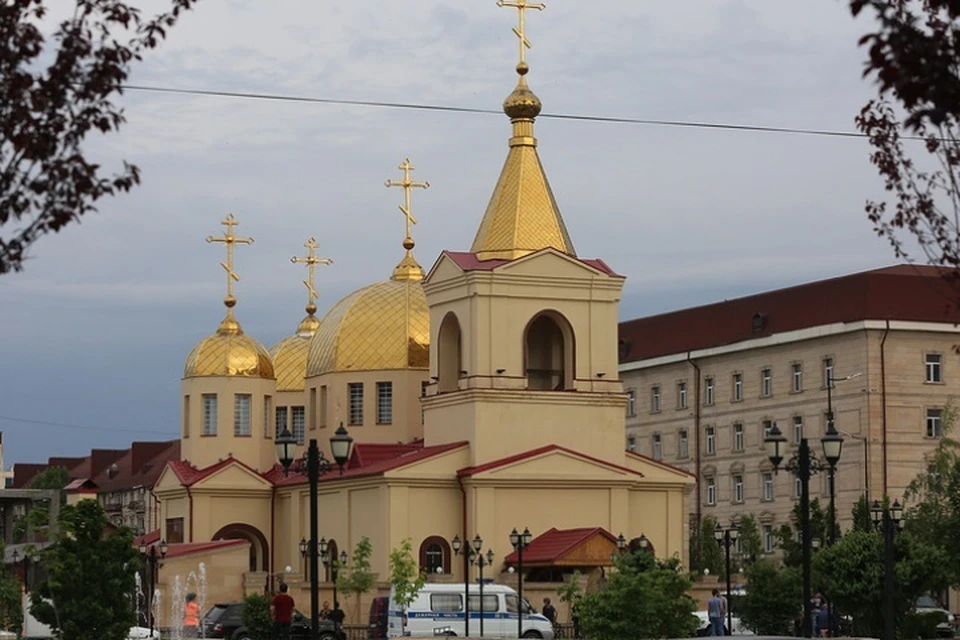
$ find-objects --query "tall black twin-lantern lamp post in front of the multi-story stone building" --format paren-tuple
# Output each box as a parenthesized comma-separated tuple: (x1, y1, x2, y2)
(763, 423, 843, 638)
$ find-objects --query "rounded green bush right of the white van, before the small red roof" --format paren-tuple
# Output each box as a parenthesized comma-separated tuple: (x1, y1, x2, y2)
(577, 551, 697, 640)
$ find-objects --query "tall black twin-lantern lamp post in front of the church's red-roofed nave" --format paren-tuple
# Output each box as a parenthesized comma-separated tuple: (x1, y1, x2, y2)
(274, 423, 353, 640)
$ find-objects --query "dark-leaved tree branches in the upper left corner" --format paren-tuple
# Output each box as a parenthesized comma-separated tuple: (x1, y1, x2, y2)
(0, 0, 197, 274)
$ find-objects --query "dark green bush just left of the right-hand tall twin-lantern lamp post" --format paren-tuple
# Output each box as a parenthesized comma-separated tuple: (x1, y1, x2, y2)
(737, 558, 803, 636)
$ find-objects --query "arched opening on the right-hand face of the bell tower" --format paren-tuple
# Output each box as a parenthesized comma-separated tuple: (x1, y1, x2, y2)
(524, 311, 573, 391)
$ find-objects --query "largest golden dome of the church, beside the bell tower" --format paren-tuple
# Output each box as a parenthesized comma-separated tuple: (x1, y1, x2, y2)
(307, 276, 430, 377)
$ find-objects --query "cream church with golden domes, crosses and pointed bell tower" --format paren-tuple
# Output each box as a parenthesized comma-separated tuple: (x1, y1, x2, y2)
(145, 0, 695, 622)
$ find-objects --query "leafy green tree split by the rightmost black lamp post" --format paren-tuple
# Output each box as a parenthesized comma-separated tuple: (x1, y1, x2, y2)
(813, 531, 946, 637)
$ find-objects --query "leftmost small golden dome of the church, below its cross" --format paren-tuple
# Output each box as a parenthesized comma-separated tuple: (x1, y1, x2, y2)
(183, 309, 273, 378)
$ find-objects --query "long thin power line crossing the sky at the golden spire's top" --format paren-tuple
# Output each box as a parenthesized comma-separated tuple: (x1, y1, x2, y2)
(123, 85, 880, 140)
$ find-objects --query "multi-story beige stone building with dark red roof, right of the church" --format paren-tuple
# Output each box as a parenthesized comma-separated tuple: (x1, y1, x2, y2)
(620, 265, 960, 551)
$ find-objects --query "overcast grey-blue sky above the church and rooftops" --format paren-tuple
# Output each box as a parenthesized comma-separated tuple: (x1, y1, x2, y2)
(0, 0, 893, 466)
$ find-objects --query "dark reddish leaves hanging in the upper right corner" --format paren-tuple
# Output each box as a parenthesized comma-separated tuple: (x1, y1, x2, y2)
(849, 0, 960, 279)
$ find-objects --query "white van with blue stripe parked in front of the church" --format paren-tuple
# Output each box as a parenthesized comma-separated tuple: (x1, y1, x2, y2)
(387, 584, 553, 640)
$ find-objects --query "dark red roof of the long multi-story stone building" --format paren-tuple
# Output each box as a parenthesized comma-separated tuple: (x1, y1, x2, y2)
(619, 265, 960, 362)
